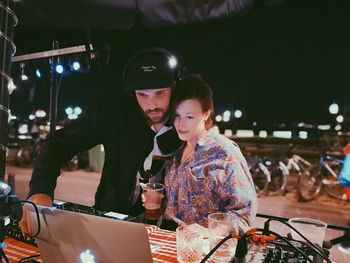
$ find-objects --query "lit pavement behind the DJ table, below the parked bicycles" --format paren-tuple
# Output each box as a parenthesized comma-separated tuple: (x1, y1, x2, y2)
(5, 165, 350, 263)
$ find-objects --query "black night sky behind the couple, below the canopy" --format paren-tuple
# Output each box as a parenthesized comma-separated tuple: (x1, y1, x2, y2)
(11, 0, 350, 128)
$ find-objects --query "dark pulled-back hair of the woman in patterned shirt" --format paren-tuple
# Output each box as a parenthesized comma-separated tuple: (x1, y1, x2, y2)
(170, 74, 214, 130)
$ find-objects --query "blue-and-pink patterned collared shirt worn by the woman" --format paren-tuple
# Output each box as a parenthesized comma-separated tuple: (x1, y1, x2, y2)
(164, 127, 257, 228)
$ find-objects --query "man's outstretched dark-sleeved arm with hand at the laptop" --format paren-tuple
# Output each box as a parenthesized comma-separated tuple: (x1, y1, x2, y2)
(20, 95, 106, 233)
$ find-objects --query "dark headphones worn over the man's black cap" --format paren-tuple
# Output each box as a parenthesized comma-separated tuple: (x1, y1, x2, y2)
(122, 47, 181, 91)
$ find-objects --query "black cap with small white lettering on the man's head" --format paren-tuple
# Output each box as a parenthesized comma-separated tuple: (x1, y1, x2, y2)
(123, 48, 178, 91)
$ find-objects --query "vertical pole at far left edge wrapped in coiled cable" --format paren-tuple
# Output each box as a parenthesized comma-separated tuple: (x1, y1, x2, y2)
(0, 0, 18, 181)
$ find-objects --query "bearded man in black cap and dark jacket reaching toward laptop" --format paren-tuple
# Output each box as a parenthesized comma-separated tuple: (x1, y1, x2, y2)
(20, 48, 180, 232)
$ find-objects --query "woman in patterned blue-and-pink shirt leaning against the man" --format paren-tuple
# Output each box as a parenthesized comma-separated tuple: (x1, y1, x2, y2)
(164, 75, 257, 230)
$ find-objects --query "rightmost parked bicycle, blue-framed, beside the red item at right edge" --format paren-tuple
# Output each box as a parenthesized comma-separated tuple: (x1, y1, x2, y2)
(298, 154, 349, 201)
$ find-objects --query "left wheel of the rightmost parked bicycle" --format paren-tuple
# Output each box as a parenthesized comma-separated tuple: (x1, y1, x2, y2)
(298, 165, 322, 201)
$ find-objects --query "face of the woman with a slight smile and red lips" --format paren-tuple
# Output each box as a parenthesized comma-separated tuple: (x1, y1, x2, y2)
(174, 99, 209, 142)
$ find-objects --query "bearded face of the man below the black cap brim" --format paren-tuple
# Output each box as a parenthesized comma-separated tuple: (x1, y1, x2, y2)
(135, 88, 171, 124)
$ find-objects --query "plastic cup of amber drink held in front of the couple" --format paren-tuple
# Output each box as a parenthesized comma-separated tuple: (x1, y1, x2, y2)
(142, 183, 164, 220)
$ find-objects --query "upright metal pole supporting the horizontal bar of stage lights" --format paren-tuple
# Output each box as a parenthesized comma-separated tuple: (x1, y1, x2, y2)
(49, 41, 59, 134)
